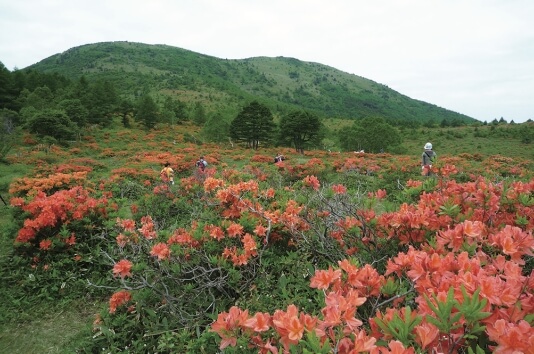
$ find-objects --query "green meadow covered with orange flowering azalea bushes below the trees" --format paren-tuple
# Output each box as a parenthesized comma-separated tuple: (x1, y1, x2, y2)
(0, 120, 534, 353)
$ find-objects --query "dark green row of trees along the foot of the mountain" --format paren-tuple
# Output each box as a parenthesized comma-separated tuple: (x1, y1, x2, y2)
(0, 62, 414, 158)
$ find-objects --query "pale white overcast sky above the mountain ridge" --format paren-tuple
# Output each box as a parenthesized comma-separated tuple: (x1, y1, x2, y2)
(0, 0, 534, 123)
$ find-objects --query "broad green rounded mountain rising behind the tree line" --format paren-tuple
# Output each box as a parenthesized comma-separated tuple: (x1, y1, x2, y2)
(24, 42, 476, 123)
